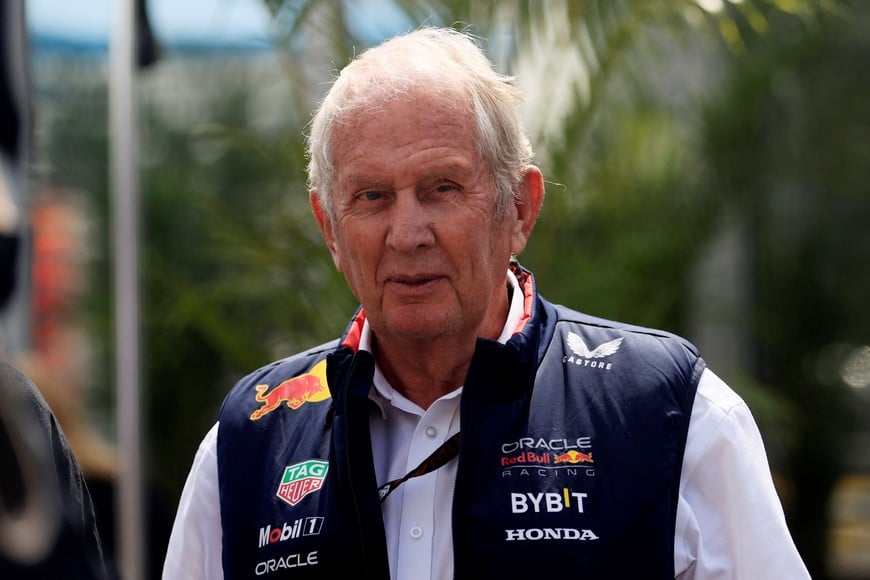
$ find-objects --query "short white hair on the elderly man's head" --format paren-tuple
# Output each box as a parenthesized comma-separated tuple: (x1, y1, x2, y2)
(306, 28, 532, 219)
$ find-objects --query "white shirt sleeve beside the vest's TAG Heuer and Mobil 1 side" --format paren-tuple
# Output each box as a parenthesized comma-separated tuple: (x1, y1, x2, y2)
(163, 424, 224, 580)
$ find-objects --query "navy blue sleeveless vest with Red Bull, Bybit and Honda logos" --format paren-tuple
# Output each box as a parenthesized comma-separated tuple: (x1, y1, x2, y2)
(218, 277, 704, 579)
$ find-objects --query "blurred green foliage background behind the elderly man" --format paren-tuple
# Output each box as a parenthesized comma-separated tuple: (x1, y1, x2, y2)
(32, 0, 870, 578)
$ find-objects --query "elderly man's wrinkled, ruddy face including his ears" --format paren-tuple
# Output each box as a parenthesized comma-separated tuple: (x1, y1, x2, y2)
(312, 92, 531, 344)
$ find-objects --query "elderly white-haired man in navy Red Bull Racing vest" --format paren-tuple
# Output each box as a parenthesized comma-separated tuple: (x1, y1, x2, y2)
(164, 29, 807, 580)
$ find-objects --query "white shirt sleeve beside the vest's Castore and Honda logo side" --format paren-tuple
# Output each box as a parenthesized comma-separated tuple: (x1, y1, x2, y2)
(674, 370, 810, 580)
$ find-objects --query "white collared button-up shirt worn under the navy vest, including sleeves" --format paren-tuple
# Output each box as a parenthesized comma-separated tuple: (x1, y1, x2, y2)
(163, 274, 809, 580)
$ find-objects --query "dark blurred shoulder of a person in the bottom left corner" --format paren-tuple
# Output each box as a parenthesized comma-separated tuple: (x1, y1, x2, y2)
(0, 362, 107, 580)
